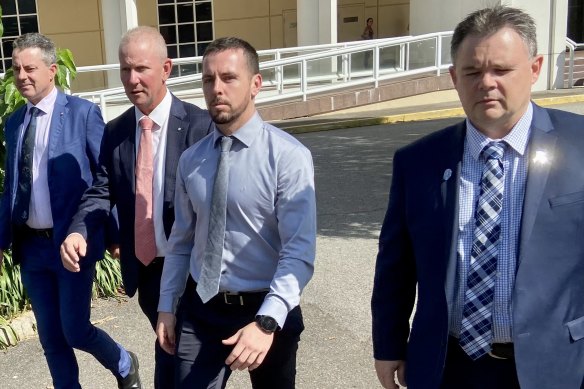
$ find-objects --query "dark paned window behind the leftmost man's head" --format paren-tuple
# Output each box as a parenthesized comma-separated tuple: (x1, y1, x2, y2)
(0, 0, 39, 72)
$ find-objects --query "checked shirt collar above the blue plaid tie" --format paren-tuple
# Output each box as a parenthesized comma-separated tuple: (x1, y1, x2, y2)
(466, 103, 533, 161)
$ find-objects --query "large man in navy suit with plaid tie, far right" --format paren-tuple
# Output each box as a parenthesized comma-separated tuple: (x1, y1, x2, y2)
(372, 6, 584, 389)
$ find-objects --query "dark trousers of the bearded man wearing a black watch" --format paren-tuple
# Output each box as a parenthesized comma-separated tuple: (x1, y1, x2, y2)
(176, 278, 304, 389)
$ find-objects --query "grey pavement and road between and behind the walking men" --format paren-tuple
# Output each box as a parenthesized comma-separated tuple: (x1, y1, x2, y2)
(0, 86, 584, 389)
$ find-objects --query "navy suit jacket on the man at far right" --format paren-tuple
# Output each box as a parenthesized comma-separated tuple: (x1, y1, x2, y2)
(372, 105, 584, 389)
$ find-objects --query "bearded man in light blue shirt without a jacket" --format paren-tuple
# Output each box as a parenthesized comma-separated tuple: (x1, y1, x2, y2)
(157, 38, 316, 388)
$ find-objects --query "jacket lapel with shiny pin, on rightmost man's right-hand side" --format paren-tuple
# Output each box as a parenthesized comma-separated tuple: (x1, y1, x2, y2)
(519, 104, 557, 255)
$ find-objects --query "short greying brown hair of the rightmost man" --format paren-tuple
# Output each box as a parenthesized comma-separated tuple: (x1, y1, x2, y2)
(450, 5, 537, 63)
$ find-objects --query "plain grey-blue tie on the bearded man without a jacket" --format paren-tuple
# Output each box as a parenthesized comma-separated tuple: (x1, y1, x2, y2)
(197, 136, 233, 303)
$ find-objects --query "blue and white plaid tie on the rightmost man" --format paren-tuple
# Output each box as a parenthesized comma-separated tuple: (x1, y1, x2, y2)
(460, 142, 505, 360)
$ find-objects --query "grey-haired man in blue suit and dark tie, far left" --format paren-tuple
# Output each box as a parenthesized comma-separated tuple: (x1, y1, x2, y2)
(0, 33, 141, 389)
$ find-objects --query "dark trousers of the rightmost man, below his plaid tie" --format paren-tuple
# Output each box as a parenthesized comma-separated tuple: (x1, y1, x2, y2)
(441, 337, 519, 389)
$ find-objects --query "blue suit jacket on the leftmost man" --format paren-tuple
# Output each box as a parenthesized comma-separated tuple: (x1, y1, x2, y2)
(0, 92, 105, 262)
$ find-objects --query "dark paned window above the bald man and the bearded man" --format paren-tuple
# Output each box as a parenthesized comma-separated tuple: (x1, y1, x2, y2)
(158, 0, 213, 76)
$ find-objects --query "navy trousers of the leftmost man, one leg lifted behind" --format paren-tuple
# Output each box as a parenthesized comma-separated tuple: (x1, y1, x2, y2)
(16, 232, 131, 389)
